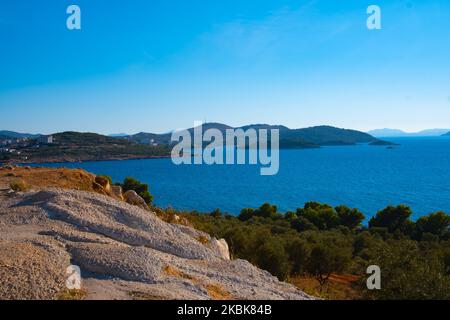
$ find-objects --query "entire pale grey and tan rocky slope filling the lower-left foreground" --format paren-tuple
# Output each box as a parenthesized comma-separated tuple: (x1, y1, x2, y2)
(0, 169, 312, 299)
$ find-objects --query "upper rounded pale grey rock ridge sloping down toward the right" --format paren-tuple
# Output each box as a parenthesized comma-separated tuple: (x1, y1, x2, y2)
(40, 190, 214, 259)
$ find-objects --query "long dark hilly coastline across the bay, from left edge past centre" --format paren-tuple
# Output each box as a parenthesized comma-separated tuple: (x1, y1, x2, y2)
(0, 123, 391, 163)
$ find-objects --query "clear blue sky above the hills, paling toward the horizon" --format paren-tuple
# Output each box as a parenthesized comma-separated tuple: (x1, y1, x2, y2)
(0, 0, 450, 133)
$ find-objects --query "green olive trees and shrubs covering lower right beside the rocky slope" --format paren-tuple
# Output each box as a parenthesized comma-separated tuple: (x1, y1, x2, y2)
(183, 202, 450, 299)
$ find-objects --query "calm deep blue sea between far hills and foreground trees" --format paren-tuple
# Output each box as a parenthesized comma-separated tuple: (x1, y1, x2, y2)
(33, 138, 450, 221)
